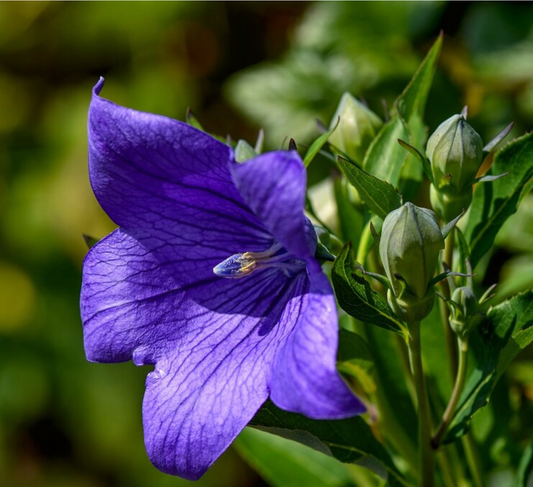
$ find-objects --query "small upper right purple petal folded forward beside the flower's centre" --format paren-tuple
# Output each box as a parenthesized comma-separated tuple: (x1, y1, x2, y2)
(231, 151, 316, 258)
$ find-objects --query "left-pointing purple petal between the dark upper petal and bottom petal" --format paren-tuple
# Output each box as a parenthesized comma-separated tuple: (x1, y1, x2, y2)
(81, 228, 308, 365)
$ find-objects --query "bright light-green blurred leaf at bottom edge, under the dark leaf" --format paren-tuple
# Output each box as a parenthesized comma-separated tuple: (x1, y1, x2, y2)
(234, 428, 355, 487)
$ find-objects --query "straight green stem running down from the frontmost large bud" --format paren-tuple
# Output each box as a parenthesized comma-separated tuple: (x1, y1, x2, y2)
(409, 321, 435, 487)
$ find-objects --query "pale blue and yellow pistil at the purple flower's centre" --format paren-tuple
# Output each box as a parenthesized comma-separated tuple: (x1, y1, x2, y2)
(213, 243, 305, 279)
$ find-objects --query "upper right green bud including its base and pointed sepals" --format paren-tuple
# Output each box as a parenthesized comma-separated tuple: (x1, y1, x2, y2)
(426, 109, 512, 220)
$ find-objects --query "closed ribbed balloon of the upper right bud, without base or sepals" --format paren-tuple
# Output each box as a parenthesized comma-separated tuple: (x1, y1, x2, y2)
(426, 115, 483, 194)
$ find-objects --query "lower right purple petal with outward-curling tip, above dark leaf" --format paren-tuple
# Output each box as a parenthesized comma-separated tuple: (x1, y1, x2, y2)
(270, 269, 366, 419)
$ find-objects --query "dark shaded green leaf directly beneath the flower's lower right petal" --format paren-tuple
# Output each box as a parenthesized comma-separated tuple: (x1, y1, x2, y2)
(250, 401, 408, 486)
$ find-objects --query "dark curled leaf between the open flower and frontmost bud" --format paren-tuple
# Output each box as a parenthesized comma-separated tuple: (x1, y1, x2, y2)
(332, 243, 407, 338)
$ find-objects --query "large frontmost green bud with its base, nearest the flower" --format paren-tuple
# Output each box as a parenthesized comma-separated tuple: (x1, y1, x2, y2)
(379, 203, 444, 321)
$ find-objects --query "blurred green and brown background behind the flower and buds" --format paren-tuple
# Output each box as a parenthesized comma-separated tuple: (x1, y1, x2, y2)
(0, 2, 533, 487)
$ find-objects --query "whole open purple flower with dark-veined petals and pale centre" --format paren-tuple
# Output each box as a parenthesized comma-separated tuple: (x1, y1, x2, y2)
(81, 80, 364, 479)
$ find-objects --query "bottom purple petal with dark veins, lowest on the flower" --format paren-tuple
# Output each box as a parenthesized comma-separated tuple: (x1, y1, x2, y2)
(143, 271, 309, 480)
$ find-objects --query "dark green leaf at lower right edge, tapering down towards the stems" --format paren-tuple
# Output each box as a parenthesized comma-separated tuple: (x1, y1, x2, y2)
(444, 291, 533, 443)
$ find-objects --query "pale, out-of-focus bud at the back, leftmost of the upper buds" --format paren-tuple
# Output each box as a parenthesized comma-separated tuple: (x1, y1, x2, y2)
(329, 93, 383, 162)
